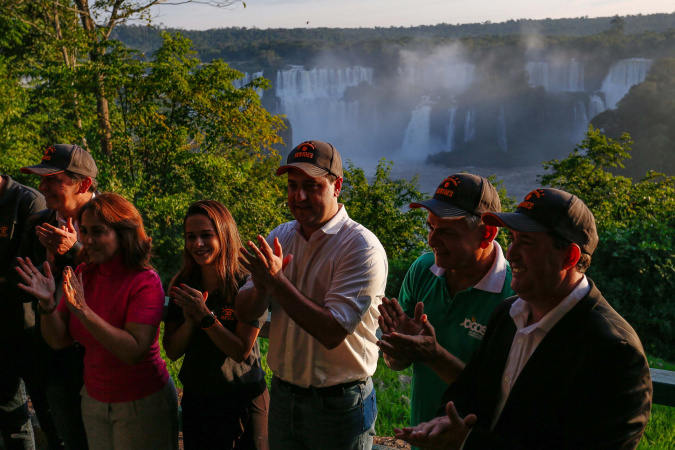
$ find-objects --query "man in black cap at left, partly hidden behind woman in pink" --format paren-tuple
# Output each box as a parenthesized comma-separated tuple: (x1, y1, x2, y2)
(7, 144, 98, 450)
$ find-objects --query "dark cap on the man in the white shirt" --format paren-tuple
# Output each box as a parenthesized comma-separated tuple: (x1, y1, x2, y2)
(277, 141, 342, 178)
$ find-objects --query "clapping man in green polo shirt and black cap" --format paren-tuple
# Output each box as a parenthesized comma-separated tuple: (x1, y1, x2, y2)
(378, 173, 514, 434)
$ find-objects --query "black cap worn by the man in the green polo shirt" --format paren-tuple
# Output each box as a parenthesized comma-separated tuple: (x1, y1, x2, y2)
(410, 173, 502, 219)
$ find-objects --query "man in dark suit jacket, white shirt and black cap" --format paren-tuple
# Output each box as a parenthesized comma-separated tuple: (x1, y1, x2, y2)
(397, 189, 652, 450)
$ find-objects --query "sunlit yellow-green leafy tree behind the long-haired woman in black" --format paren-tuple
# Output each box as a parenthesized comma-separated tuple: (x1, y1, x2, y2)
(99, 33, 284, 279)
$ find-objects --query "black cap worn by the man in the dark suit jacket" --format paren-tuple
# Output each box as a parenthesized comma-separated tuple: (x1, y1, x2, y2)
(483, 188, 598, 255)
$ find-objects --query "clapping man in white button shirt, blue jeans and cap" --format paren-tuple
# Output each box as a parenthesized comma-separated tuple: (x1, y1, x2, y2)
(236, 140, 387, 449)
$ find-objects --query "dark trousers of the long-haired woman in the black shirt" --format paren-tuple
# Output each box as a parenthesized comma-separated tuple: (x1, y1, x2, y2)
(181, 389, 269, 450)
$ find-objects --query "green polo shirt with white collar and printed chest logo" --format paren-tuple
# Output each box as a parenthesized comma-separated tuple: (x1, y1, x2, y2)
(398, 242, 514, 426)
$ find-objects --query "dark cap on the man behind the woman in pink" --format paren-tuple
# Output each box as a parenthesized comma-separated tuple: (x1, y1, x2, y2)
(21, 144, 98, 178)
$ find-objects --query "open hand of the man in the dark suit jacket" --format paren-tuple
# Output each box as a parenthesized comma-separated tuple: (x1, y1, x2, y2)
(394, 402, 476, 449)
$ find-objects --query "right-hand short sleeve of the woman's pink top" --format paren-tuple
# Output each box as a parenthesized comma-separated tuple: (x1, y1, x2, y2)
(126, 270, 164, 326)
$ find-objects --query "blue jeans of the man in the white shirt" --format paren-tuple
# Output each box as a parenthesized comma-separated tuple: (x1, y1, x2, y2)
(269, 377, 377, 450)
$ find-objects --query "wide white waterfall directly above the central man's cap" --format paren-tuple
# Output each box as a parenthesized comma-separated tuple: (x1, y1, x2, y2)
(276, 66, 373, 151)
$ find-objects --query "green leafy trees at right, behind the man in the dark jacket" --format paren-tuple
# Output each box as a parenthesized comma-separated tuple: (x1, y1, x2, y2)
(542, 127, 675, 360)
